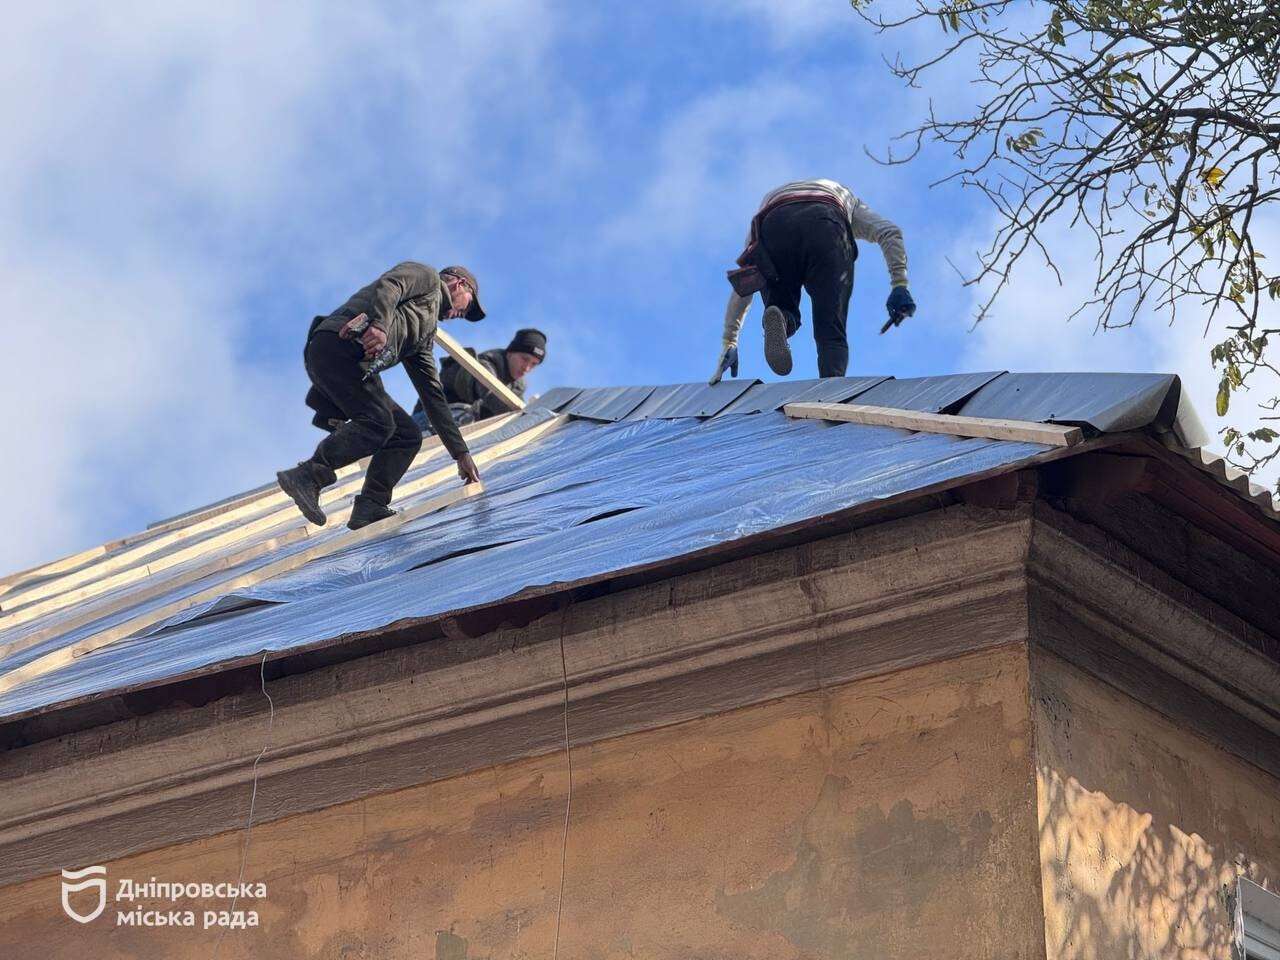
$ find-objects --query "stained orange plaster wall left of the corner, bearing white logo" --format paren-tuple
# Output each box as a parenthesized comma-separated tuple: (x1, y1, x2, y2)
(0, 646, 1043, 960)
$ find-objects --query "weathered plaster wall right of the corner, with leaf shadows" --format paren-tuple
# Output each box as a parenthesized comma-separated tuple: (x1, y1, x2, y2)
(1032, 652, 1280, 960)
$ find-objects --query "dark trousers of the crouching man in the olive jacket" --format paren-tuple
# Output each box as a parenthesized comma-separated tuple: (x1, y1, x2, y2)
(302, 330, 422, 506)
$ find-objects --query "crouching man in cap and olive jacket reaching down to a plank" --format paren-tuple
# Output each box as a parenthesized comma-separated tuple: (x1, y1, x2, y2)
(275, 260, 484, 530)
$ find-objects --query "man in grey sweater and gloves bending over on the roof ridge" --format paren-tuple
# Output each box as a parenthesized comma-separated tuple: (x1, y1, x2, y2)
(710, 179, 915, 384)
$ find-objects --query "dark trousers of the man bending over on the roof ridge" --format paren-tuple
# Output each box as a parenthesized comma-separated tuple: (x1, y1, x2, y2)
(760, 202, 858, 376)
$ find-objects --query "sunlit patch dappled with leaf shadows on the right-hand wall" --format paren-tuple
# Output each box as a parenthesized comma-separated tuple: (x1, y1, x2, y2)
(1037, 765, 1262, 960)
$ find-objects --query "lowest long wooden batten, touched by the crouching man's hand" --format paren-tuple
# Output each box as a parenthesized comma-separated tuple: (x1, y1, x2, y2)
(0, 416, 568, 694)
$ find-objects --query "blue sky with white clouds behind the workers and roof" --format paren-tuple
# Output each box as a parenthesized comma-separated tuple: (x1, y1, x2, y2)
(0, 0, 1264, 570)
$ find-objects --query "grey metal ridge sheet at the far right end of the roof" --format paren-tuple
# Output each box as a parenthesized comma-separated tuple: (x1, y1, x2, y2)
(959, 374, 1181, 433)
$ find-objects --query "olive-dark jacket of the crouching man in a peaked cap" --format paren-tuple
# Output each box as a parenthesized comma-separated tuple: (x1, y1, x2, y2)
(307, 260, 467, 460)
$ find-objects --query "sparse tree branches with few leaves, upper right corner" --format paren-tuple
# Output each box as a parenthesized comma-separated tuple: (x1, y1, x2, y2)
(850, 0, 1280, 491)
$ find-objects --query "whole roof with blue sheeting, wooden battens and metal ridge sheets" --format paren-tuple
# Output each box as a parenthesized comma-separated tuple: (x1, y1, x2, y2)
(0, 371, 1277, 721)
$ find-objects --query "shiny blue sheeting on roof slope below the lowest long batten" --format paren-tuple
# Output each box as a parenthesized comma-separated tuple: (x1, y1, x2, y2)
(0, 413, 1047, 717)
